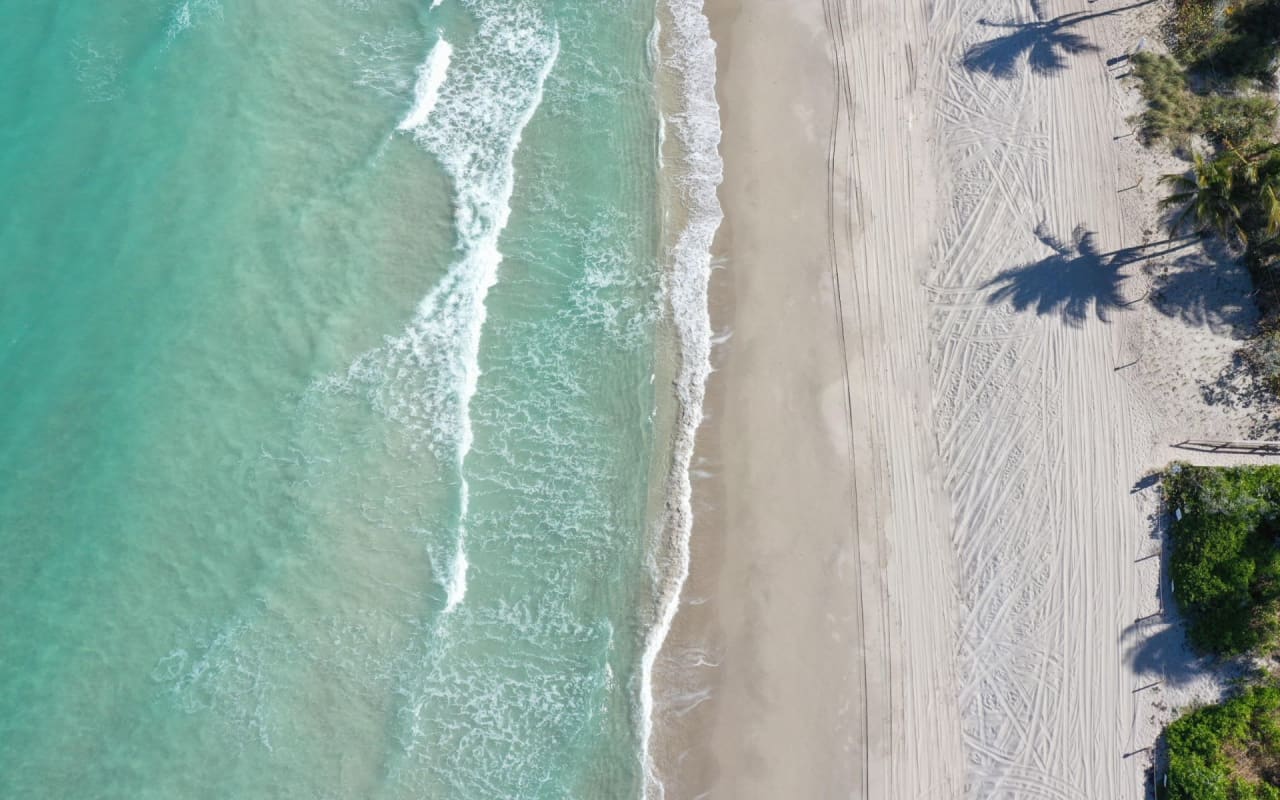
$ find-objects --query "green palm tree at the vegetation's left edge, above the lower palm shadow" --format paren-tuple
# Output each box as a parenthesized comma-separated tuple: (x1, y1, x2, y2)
(1160, 154, 1249, 243)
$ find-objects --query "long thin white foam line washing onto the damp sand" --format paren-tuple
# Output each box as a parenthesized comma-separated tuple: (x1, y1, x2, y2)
(640, 0, 723, 799)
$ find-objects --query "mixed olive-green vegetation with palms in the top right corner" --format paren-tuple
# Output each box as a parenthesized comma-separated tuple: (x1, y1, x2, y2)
(1132, 0, 1280, 384)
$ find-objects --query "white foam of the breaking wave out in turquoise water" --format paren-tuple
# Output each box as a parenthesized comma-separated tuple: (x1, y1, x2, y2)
(330, 0, 559, 624)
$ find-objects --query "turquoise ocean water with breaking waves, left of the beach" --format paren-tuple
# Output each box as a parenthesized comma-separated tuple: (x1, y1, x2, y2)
(0, 0, 718, 800)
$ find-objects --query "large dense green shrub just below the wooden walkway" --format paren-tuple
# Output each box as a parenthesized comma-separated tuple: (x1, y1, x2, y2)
(1165, 463, 1280, 655)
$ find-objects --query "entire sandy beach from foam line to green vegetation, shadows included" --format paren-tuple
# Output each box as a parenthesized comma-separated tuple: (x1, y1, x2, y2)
(654, 0, 1274, 799)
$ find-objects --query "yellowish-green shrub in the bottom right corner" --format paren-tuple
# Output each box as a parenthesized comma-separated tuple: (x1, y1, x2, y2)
(1158, 685, 1280, 800)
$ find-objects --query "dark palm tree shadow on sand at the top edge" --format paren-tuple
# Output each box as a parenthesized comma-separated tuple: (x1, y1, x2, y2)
(964, 0, 1155, 79)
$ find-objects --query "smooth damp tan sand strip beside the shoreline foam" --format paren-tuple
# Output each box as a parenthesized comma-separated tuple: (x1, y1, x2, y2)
(654, 0, 948, 799)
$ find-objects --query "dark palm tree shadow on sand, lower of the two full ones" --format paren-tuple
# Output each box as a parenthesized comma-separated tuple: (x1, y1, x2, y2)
(983, 223, 1194, 328)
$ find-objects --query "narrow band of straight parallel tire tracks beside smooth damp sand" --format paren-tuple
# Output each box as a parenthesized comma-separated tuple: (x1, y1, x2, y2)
(823, 0, 963, 797)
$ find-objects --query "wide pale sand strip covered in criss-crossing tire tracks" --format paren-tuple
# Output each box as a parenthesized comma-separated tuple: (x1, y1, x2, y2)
(927, 0, 1167, 800)
